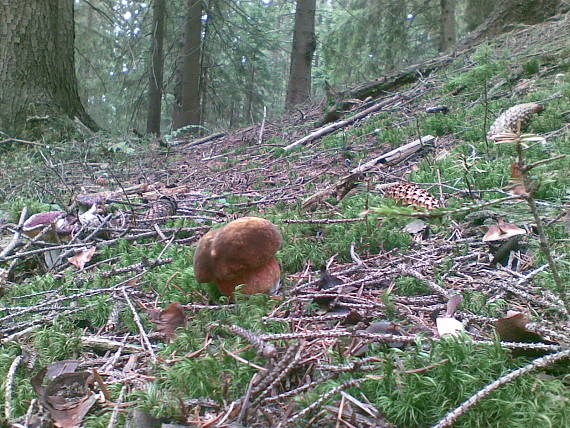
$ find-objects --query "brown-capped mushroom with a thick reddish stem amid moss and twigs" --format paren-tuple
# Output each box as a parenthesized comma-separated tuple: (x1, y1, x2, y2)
(194, 217, 281, 296)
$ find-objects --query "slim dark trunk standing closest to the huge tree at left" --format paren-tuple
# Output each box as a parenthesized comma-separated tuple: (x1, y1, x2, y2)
(146, 0, 166, 135)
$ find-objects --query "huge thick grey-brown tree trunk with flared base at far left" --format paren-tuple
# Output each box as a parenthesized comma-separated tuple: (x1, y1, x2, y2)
(0, 0, 97, 137)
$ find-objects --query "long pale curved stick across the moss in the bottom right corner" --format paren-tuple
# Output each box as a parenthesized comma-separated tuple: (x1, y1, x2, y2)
(433, 350, 570, 428)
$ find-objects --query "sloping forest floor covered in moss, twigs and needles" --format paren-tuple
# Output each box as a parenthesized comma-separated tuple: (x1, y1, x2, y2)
(0, 10, 570, 427)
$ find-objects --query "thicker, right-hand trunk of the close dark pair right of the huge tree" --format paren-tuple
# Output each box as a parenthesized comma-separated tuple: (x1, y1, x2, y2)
(173, 0, 202, 129)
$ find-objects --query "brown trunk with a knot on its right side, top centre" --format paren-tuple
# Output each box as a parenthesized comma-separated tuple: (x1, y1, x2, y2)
(285, 0, 317, 109)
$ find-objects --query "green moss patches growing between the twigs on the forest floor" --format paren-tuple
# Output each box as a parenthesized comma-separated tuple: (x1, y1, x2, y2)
(0, 21, 570, 427)
